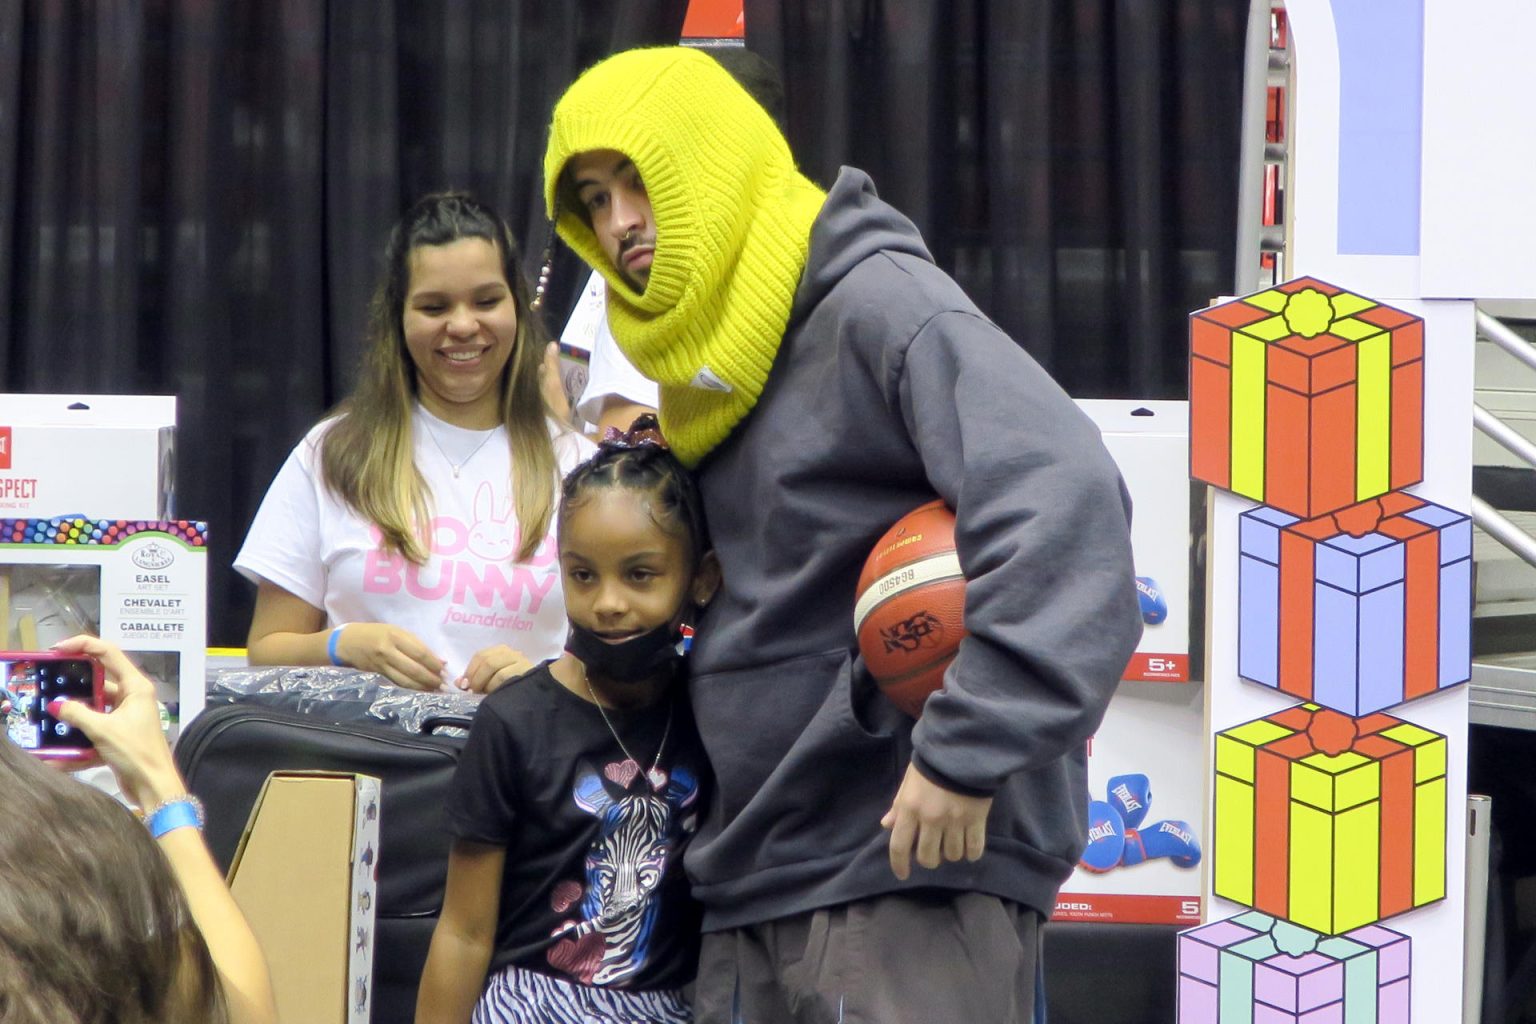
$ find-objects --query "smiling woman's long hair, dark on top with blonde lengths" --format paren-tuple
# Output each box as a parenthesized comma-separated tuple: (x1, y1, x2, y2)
(319, 192, 559, 565)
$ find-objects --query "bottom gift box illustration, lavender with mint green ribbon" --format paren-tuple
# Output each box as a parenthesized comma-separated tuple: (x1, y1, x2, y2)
(1178, 912, 1412, 1024)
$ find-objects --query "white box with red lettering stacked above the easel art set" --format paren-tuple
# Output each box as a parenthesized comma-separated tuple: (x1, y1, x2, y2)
(0, 395, 177, 519)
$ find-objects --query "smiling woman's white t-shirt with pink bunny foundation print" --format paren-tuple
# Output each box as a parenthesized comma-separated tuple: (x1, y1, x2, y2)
(235, 405, 594, 679)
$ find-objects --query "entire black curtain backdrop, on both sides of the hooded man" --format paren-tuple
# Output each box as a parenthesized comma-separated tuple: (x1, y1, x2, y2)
(0, 0, 1246, 645)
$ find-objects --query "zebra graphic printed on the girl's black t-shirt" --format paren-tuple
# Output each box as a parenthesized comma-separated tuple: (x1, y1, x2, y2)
(547, 768, 699, 986)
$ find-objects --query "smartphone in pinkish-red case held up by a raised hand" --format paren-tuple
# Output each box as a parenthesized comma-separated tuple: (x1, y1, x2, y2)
(0, 651, 106, 761)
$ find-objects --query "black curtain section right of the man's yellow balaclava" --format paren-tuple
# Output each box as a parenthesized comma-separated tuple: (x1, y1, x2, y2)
(745, 0, 1247, 398)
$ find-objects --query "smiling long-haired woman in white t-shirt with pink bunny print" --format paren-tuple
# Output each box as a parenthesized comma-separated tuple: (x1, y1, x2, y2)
(235, 193, 591, 692)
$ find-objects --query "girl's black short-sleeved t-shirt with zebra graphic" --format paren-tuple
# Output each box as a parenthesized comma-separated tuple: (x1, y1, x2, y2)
(449, 663, 708, 990)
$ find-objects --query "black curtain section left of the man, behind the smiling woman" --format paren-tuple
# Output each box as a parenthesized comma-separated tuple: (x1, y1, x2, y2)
(0, 0, 687, 645)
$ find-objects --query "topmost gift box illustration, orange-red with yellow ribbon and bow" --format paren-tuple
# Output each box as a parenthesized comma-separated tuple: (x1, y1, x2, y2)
(1189, 278, 1424, 517)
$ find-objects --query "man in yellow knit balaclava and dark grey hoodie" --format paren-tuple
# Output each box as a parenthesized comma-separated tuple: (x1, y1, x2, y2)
(544, 48, 1141, 1024)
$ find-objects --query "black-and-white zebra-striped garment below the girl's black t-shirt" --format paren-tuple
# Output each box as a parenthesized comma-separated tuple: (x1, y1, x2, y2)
(470, 964, 693, 1024)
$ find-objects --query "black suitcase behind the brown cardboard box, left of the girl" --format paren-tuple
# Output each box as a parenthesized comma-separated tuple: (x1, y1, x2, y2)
(175, 703, 468, 1024)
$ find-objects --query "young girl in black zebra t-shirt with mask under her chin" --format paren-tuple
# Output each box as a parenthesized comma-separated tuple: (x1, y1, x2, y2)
(416, 418, 719, 1024)
